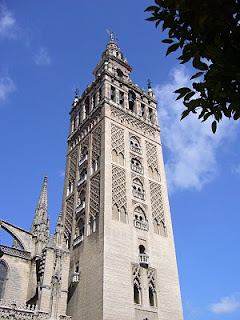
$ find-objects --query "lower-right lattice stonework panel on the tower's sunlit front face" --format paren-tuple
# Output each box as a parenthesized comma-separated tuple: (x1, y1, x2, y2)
(149, 181, 165, 222)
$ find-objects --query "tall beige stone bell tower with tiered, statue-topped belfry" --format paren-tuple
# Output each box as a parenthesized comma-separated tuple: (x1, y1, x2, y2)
(62, 33, 183, 320)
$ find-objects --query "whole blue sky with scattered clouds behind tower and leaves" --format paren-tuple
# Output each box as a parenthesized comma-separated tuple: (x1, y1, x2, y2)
(0, 0, 240, 320)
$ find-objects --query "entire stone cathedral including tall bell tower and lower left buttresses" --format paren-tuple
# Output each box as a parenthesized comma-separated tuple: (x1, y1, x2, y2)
(0, 33, 183, 320)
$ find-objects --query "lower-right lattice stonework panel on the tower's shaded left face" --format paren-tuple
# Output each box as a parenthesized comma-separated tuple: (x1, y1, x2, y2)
(90, 173, 100, 217)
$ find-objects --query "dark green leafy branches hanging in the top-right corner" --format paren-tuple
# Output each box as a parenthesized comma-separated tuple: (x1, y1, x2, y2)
(145, 0, 240, 133)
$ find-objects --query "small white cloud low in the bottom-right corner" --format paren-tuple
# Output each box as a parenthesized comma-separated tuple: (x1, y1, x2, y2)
(209, 293, 240, 314)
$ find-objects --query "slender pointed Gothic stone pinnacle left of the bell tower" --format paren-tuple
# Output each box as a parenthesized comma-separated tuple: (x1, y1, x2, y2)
(30, 176, 49, 240)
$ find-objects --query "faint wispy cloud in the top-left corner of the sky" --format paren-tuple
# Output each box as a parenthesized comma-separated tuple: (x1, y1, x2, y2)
(0, 4, 16, 38)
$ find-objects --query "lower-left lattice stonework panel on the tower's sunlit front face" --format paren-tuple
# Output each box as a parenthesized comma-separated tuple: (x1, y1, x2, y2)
(112, 165, 127, 209)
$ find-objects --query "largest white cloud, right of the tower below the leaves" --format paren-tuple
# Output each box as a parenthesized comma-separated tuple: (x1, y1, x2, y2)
(154, 67, 234, 192)
